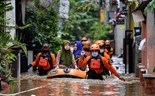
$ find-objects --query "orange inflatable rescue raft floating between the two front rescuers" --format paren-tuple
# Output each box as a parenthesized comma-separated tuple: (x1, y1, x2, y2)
(47, 68, 86, 79)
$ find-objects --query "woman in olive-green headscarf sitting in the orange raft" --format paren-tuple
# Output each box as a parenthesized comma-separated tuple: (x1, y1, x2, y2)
(56, 40, 78, 69)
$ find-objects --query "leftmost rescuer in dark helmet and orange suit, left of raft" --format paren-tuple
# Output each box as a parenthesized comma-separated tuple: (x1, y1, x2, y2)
(28, 43, 56, 75)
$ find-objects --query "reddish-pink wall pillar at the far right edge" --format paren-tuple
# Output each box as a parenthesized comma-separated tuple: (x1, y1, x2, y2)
(142, 12, 155, 73)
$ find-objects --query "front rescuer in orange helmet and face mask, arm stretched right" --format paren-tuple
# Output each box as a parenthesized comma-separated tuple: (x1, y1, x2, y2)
(78, 44, 125, 81)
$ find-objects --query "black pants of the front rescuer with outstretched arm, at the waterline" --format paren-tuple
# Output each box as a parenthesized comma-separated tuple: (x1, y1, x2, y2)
(87, 70, 104, 80)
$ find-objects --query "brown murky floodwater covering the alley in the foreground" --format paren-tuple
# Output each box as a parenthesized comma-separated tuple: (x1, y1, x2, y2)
(0, 77, 150, 96)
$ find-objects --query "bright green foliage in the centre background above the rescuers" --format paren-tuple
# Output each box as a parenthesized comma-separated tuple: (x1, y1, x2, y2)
(63, 0, 112, 41)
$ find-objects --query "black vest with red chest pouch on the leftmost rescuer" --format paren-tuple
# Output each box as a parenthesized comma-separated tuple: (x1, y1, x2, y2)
(38, 53, 53, 70)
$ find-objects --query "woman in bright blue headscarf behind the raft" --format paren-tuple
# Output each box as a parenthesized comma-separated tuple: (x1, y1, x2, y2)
(73, 41, 82, 60)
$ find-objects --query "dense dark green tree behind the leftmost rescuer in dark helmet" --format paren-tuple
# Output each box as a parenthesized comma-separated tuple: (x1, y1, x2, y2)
(26, 0, 62, 53)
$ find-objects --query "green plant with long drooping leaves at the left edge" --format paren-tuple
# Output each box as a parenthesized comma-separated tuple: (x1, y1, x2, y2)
(0, 32, 27, 81)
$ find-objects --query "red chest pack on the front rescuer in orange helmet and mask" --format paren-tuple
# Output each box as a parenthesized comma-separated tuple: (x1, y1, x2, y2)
(88, 56, 104, 70)
